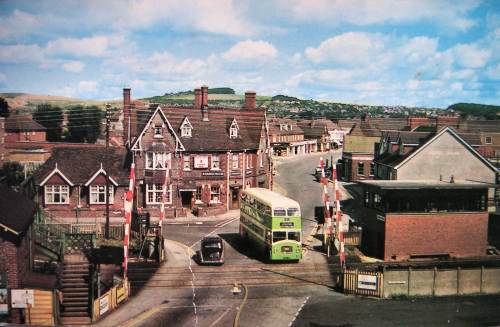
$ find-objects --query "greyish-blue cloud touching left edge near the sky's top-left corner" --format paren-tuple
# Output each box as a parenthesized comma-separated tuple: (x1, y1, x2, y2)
(0, 9, 40, 40)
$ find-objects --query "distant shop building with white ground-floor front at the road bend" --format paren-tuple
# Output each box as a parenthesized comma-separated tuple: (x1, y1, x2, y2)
(269, 118, 317, 157)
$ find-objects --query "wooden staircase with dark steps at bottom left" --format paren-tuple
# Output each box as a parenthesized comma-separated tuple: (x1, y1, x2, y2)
(59, 255, 91, 325)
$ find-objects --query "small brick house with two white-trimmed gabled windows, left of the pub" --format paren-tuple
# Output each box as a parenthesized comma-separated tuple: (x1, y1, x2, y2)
(33, 145, 130, 222)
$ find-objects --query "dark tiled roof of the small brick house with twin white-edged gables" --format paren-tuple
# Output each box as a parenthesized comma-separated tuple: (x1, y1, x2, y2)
(34, 146, 130, 185)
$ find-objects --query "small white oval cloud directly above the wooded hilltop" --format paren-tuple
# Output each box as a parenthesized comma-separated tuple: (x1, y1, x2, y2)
(222, 40, 278, 64)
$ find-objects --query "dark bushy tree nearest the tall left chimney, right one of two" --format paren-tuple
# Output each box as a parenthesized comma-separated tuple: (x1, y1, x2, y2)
(68, 105, 104, 143)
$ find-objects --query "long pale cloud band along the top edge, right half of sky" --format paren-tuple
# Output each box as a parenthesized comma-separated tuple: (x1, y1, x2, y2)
(276, 0, 479, 31)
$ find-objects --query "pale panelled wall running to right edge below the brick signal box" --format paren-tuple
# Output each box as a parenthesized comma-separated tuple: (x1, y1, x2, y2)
(383, 267, 500, 298)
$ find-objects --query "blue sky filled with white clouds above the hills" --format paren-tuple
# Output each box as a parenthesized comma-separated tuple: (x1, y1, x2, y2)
(0, 0, 500, 108)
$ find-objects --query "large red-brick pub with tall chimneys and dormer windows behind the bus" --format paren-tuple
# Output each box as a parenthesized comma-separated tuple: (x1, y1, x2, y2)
(124, 86, 270, 217)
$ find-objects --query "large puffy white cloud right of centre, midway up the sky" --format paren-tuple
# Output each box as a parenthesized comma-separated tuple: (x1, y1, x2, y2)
(305, 32, 385, 65)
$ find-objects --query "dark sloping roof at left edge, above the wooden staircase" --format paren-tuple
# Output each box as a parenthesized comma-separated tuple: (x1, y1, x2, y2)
(0, 184, 36, 234)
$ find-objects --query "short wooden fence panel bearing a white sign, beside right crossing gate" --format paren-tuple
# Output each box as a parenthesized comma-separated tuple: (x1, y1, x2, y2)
(343, 269, 383, 297)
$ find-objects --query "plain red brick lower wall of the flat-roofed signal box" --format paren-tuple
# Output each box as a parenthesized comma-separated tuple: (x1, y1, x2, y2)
(384, 212, 488, 260)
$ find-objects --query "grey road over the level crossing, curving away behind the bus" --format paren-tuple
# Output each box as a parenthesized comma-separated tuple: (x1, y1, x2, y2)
(109, 153, 500, 327)
